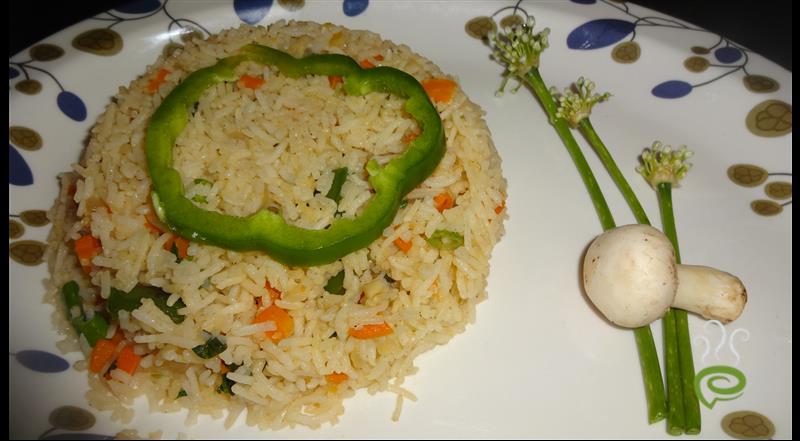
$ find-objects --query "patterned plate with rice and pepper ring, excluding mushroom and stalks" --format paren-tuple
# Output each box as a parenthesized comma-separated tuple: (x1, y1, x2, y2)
(9, 0, 792, 439)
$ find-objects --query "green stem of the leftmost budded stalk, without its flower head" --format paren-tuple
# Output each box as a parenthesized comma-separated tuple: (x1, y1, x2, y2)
(524, 69, 666, 424)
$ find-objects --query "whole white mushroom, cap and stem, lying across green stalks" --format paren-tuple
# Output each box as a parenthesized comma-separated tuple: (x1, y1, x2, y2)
(583, 225, 747, 328)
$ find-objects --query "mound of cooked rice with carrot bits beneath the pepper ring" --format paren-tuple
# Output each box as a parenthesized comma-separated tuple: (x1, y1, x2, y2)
(48, 21, 506, 429)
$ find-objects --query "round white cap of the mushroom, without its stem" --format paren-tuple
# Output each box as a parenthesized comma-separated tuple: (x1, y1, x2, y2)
(583, 225, 678, 328)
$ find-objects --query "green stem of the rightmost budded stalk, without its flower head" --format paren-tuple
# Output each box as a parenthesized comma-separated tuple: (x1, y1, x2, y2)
(657, 182, 701, 435)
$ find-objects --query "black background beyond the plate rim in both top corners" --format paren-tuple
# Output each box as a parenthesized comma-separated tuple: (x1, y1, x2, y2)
(8, 0, 792, 70)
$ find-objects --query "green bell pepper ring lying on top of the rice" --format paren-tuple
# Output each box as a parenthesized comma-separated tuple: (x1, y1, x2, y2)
(145, 44, 445, 266)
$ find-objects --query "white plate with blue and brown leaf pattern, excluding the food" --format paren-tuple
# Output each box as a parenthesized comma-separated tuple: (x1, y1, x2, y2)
(9, 0, 792, 439)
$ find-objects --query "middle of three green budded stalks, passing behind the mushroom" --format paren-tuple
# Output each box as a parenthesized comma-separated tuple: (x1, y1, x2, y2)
(550, 77, 697, 435)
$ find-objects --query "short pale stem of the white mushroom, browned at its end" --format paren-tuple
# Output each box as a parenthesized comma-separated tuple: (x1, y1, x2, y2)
(672, 265, 747, 323)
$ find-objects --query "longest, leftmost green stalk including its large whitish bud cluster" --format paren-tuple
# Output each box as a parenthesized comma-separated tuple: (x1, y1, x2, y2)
(489, 16, 666, 424)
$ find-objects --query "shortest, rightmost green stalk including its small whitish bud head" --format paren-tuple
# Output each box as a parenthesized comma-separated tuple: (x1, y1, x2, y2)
(636, 141, 701, 435)
